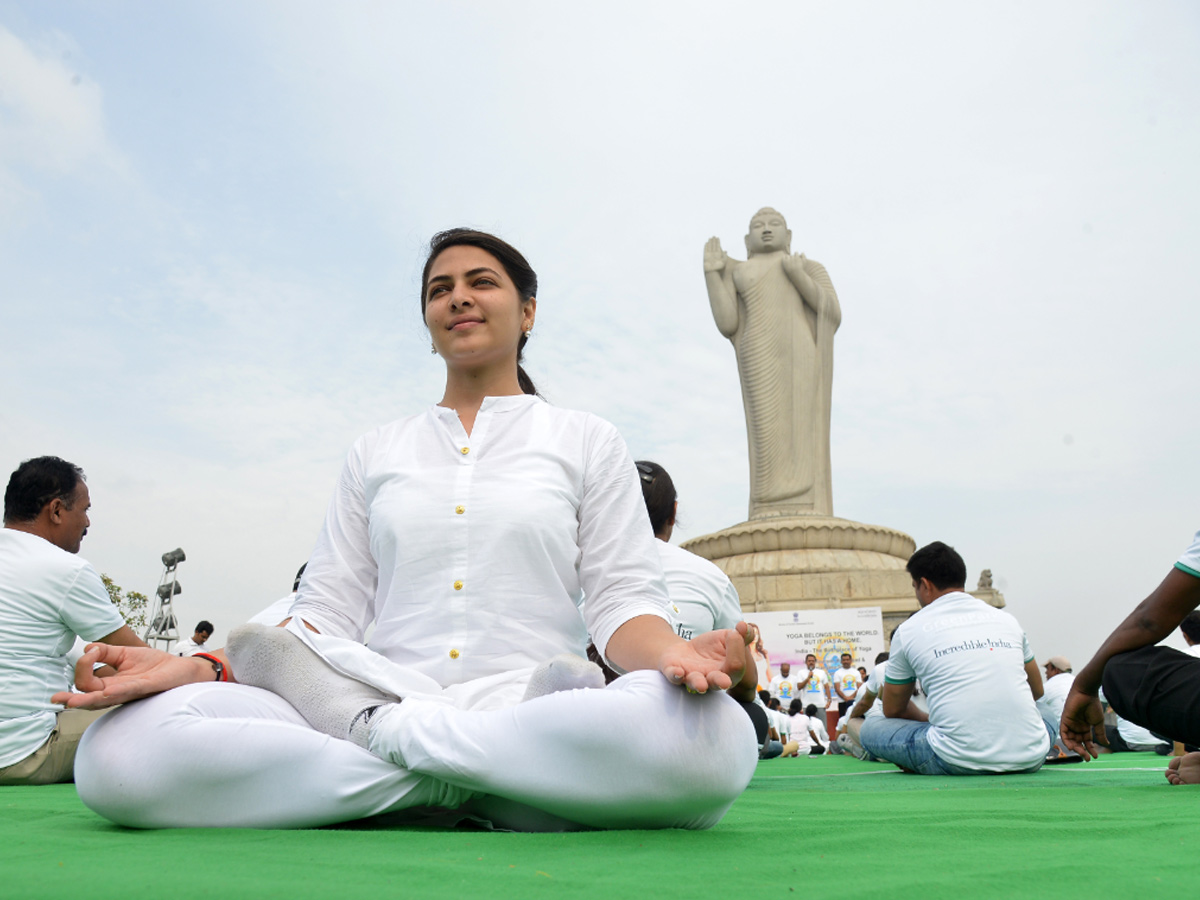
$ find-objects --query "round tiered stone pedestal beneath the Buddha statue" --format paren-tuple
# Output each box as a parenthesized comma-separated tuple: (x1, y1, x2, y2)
(682, 516, 1004, 635)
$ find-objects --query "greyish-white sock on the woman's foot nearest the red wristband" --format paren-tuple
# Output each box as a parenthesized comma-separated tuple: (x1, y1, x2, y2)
(226, 625, 400, 749)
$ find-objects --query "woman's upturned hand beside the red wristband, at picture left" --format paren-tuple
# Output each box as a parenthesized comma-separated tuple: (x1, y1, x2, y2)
(50, 643, 214, 709)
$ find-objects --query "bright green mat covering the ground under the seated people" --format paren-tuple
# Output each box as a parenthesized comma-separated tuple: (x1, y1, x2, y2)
(0, 754, 1200, 900)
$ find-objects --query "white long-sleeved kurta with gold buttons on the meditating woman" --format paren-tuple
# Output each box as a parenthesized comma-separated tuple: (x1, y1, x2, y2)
(285, 395, 671, 708)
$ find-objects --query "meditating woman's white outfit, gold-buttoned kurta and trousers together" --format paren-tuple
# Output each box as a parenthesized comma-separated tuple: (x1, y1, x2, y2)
(76, 396, 756, 828)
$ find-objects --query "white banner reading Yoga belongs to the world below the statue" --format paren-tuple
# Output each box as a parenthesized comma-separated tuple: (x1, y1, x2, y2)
(745, 606, 884, 685)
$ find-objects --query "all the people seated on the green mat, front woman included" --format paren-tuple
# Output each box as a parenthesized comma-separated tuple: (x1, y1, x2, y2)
(0, 229, 1200, 830)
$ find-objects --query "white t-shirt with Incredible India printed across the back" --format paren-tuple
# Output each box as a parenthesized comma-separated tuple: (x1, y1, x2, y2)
(886, 590, 1050, 772)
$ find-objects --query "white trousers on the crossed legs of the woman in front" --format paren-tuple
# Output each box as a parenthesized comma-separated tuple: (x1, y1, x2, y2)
(76, 672, 757, 830)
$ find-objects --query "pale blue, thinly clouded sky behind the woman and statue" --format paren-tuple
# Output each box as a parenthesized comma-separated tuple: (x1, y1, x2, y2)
(0, 0, 1200, 668)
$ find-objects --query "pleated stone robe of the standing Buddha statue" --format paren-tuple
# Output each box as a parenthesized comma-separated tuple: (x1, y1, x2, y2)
(732, 254, 841, 518)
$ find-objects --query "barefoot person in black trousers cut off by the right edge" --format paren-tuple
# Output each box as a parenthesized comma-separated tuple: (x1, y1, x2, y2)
(1060, 532, 1200, 785)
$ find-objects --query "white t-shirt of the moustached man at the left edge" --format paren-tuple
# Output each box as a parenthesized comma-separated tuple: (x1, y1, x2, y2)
(0, 528, 125, 768)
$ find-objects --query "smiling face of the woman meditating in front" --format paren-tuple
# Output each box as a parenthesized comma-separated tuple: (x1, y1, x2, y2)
(425, 246, 538, 368)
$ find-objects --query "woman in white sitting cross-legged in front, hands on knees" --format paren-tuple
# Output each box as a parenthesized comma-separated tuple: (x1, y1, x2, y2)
(62, 230, 756, 829)
